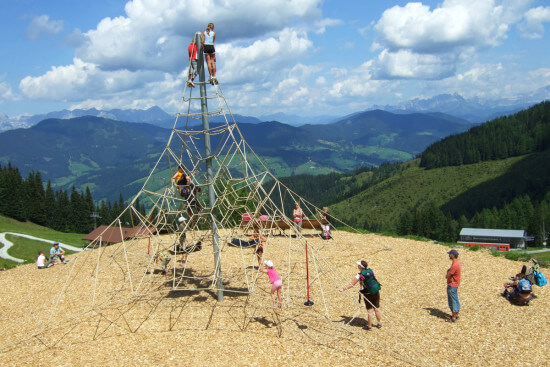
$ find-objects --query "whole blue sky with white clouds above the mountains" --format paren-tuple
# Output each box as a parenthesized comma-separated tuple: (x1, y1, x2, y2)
(0, 0, 550, 116)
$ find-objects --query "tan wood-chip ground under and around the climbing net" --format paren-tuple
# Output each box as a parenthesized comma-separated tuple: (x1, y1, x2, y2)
(0, 231, 550, 366)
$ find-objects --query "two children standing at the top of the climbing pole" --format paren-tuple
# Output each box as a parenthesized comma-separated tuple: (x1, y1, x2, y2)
(187, 23, 218, 88)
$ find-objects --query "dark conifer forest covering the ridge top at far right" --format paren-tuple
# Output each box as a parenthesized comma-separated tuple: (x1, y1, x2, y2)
(420, 102, 550, 169)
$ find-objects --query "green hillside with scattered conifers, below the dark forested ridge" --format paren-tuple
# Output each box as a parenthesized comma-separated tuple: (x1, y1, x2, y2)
(287, 151, 550, 243)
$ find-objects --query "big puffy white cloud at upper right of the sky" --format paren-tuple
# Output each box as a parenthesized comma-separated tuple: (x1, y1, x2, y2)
(371, 0, 531, 79)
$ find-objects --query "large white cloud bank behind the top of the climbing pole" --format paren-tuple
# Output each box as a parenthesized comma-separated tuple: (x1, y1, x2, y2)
(19, 0, 326, 113)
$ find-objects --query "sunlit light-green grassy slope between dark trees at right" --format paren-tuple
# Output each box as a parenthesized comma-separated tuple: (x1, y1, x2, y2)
(331, 157, 524, 230)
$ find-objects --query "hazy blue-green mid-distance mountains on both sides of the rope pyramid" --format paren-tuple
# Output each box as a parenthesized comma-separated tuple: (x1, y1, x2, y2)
(0, 110, 471, 200)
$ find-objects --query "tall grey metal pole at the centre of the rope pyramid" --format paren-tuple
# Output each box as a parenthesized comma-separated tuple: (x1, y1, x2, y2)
(195, 32, 223, 302)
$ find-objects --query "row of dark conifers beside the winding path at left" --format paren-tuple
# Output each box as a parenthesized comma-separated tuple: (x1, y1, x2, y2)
(0, 163, 145, 233)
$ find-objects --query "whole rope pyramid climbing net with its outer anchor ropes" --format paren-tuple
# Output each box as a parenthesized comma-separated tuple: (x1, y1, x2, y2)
(2, 33, 440, 365)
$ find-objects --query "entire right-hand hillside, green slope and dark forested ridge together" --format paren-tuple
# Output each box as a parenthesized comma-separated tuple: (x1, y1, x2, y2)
(288, 103, 550, 243)
